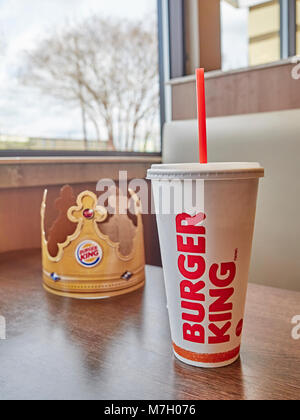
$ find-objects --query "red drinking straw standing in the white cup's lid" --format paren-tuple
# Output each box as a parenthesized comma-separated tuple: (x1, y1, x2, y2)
(196, 69, 207, 163)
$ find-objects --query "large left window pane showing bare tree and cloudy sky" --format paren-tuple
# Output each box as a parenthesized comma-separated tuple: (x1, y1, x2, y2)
(0, 0, 160, 152)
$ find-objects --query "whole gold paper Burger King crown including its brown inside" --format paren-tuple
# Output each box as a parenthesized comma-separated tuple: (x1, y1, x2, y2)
(41, 186, 145, 299)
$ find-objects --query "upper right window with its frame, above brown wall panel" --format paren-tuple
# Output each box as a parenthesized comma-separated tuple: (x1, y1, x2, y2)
(176, 0, 300, 77)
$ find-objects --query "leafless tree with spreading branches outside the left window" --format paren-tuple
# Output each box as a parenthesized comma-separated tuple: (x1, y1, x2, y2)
(20, 16, 159, 150)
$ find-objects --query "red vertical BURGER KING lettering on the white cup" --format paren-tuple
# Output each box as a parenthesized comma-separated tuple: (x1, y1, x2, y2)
(176, 213, 236, 344)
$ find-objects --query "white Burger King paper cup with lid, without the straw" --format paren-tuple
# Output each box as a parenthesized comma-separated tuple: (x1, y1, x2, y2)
(148, 163, 264, 368)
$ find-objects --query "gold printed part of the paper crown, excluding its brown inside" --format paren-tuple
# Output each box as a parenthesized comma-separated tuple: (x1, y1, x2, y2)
(41, 187, 145, 299)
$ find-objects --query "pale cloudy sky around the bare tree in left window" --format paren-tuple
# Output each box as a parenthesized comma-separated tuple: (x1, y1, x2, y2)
(0, 0, 156, 138)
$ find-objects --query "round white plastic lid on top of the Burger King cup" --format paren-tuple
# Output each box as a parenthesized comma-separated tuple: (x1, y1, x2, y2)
(147, 162, 264, 180)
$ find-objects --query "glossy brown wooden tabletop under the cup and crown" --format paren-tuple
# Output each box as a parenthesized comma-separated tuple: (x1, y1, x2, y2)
(0, 251, 300, 400)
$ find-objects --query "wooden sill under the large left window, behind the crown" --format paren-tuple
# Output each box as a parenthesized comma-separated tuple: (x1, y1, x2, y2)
(0, 156, 161, 189)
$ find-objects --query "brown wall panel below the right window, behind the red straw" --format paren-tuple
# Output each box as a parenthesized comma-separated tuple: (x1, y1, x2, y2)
(171, 57, 300, 120)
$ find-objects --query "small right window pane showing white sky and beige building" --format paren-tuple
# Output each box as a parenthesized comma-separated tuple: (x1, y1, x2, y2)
(221, 0, 280, 70)
